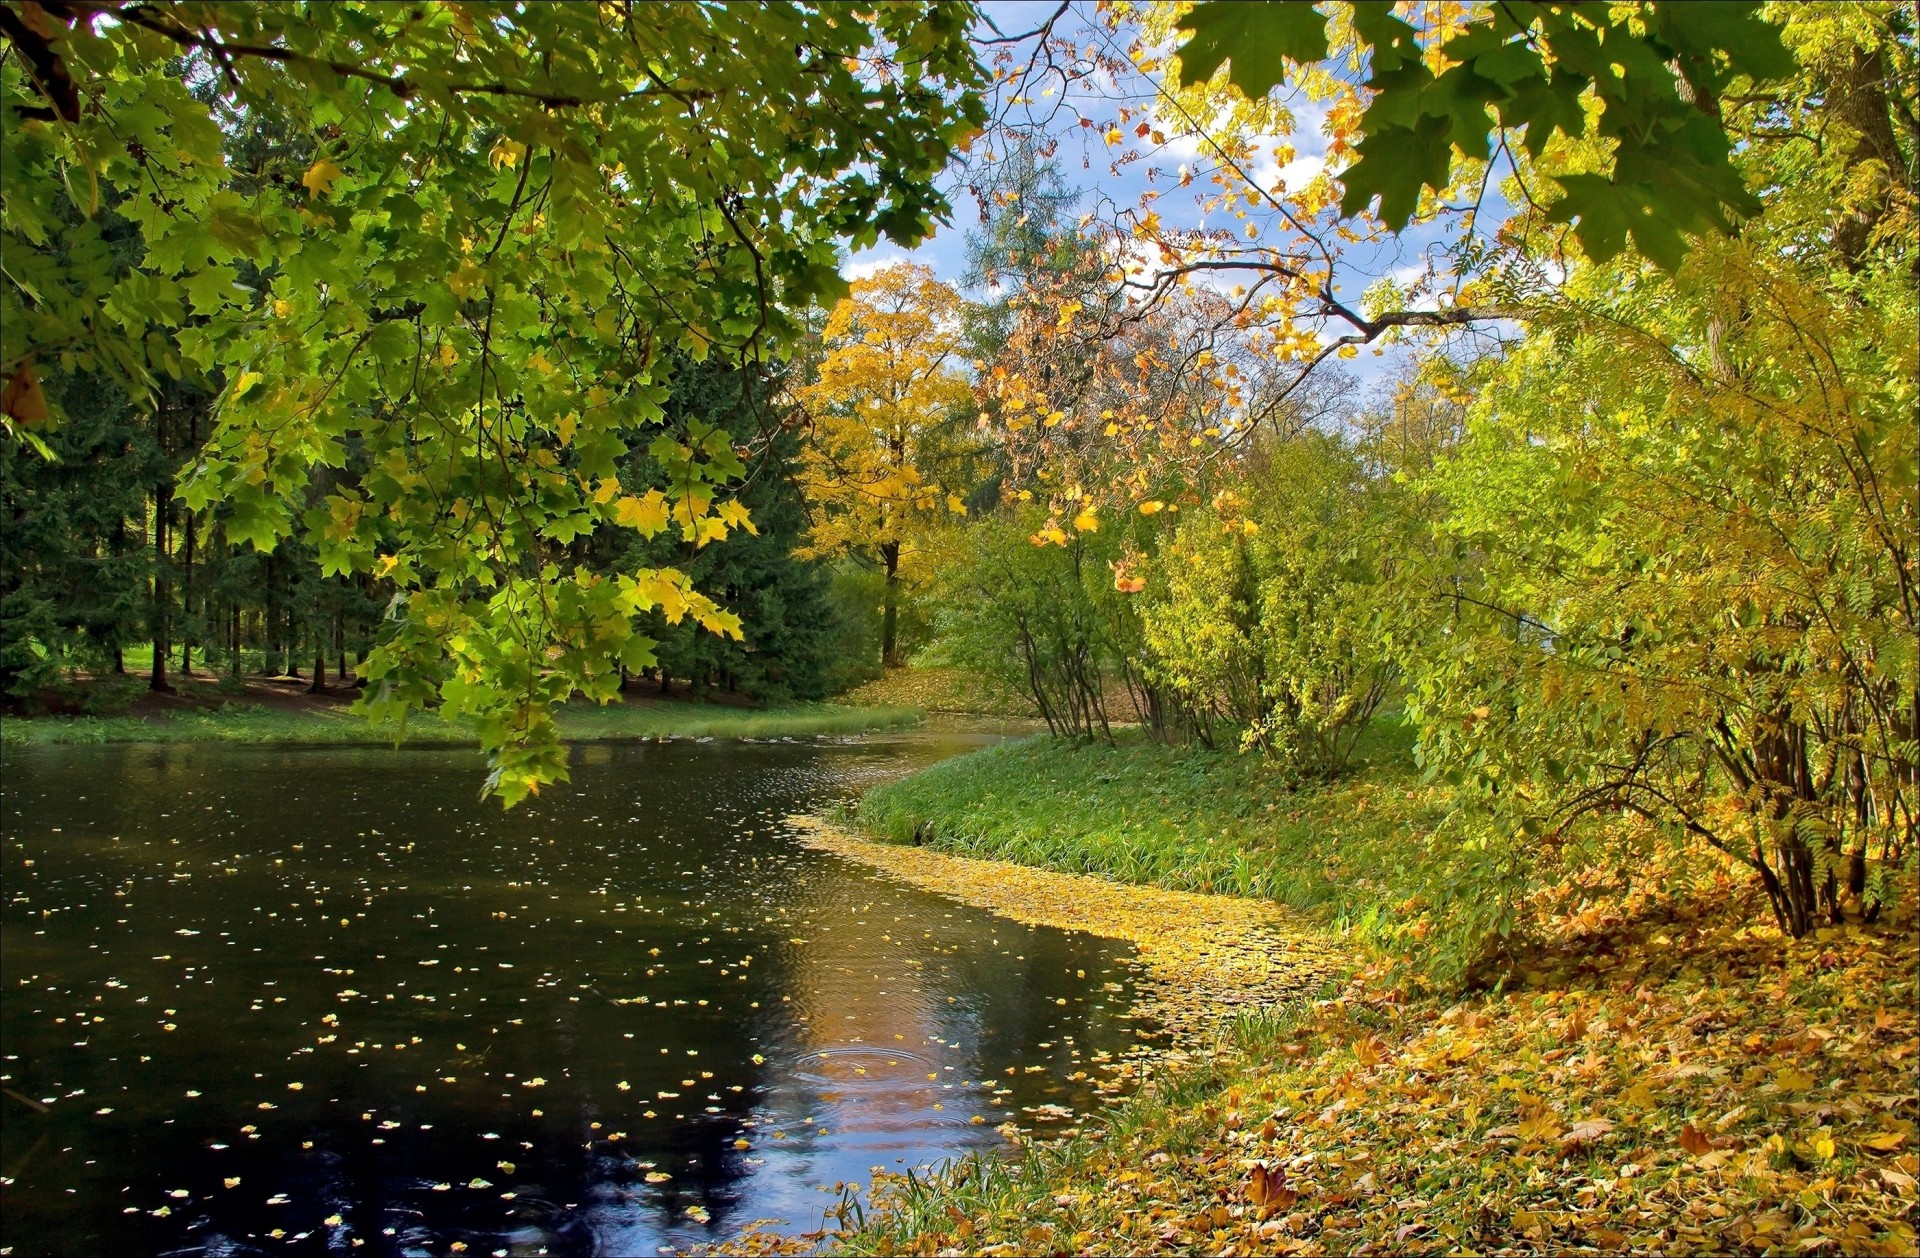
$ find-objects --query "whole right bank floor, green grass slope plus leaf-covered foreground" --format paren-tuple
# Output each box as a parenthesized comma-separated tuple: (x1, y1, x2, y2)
(768, 726, 1920, 1254)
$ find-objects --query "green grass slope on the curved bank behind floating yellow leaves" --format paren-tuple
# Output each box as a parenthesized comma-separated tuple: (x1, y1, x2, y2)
(852, 720, 1446, 933)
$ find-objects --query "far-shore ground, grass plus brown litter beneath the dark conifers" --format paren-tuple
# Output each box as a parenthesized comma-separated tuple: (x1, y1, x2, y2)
(0, 674, 924, 745)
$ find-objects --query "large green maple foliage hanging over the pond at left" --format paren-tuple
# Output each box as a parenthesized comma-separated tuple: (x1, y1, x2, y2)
(0, 2, 981, 801)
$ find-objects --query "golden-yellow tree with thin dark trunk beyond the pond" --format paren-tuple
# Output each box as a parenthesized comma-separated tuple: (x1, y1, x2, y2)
(799, 263, 973, 665)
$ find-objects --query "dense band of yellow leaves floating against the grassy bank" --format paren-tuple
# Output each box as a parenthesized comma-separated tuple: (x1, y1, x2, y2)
(787, 816, 1348, 1051)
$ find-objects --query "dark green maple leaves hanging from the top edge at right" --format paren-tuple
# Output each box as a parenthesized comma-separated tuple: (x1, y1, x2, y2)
(1179, 0, 1793, 271)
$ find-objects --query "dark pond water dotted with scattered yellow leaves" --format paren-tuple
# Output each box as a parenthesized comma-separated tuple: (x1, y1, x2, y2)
(0, 734, 1135, 1254)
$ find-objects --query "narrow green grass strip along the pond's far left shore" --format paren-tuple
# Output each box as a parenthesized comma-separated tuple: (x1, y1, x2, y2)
(0, 699, 922, 745)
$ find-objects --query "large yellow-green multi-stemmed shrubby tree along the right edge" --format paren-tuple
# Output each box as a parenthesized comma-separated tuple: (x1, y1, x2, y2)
(1411, 6, 1920, 935)
